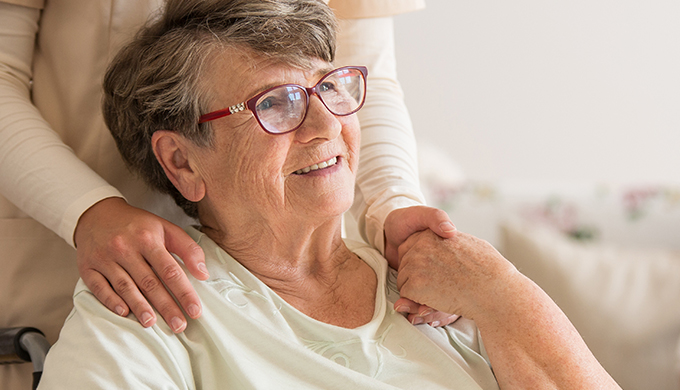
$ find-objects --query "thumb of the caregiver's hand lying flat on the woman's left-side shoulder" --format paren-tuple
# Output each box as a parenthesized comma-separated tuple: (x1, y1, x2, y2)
(163, 221, 210, 280)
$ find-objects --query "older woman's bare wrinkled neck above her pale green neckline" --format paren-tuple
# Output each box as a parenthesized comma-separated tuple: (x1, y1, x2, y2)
(202, 213, 377, 328)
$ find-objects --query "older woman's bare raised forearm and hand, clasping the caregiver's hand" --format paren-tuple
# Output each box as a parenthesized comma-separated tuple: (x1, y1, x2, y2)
(397, 231, 620, 390)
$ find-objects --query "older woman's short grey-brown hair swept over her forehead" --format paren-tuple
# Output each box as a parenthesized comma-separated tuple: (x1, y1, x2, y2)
(103, 0, 336, 218)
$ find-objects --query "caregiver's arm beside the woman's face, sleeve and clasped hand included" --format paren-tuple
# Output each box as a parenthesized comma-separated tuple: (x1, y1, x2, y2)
(336, 17, 457, 325)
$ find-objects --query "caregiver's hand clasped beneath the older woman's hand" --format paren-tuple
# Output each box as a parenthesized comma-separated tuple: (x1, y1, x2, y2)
(384, 206, 458, 326)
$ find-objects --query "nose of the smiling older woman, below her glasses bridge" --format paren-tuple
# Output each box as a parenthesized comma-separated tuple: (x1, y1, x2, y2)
(295, 95, 342, 143)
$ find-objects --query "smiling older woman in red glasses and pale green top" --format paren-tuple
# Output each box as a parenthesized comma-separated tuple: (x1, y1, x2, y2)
(41, 0, 616, 389)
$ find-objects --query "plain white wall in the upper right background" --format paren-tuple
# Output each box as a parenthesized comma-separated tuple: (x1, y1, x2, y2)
(395, 0, 680, 184)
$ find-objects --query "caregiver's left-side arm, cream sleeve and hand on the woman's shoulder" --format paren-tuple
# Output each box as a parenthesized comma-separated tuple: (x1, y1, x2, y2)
(0, 2, 207, 332)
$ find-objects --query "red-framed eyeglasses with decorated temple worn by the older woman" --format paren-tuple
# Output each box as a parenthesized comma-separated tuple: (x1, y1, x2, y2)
(198, 66, 368, 134)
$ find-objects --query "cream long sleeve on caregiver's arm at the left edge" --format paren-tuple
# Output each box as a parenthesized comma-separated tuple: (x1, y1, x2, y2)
(0, 3, 122, 245)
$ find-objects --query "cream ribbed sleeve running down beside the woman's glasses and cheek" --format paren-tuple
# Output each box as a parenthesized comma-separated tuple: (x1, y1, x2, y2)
(336, 17, 425, 252)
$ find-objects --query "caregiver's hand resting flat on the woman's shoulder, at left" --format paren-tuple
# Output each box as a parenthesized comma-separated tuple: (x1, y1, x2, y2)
(74, 198, 209, 333)
